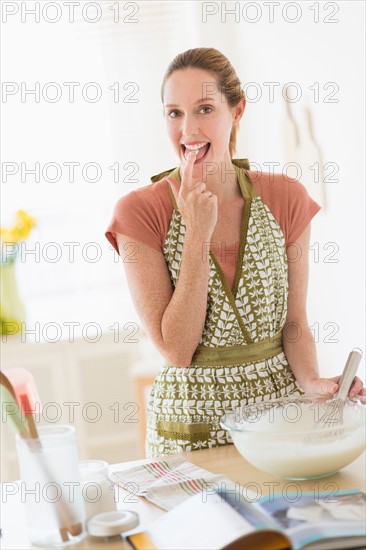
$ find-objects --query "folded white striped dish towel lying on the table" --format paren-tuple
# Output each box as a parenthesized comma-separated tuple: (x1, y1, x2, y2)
(108, 457, 237, 510)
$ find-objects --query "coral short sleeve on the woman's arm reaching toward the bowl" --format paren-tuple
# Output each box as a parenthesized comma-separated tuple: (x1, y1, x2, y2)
(287, 179, 321, 243)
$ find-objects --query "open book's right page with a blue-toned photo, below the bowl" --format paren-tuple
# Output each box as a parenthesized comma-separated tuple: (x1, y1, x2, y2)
(260, 490, 366, 550)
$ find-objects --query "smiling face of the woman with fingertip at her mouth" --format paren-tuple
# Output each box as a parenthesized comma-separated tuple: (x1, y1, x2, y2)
(164, 68, 245, 177)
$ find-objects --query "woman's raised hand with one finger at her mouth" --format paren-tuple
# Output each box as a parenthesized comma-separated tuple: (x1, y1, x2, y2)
(166, 151, 218, 240)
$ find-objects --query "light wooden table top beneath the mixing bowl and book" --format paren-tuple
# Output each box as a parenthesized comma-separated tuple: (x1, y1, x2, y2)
(0, 445, 366, 550)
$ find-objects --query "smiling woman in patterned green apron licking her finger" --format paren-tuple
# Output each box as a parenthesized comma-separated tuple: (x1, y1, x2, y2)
(106, 48, 362, 458)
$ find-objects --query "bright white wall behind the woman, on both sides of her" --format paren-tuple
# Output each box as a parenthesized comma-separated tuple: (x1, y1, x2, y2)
(2, 2, 365, 380)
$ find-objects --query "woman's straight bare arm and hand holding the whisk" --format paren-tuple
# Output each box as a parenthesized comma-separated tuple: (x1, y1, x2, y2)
(282, 224, 366, 402)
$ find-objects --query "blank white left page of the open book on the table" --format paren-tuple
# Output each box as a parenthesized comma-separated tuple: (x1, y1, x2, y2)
(129, 493, 289, 550)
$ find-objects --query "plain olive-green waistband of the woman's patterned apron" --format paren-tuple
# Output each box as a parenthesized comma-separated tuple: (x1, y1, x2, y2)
(183, 331, 283, 367)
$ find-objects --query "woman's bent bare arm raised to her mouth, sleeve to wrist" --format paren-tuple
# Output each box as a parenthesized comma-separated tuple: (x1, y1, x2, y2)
(116, 231, 209, 367)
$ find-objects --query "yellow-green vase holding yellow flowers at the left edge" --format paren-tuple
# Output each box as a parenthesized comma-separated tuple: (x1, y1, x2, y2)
(0, 259, 26, 334)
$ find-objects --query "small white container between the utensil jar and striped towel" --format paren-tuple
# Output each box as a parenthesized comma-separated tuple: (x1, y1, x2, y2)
(79, 460, 116, 518)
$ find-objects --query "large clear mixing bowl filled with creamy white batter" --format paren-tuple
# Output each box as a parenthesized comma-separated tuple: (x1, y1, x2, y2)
(221, 395, 366, 479)
